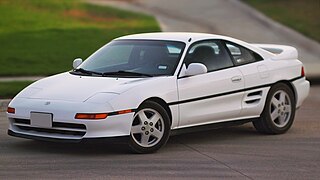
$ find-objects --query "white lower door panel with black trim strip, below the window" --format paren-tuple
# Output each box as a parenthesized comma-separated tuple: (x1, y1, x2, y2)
(178, 68, 244, 127)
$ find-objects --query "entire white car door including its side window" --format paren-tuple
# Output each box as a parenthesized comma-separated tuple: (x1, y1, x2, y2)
(177, 40, 244, 127)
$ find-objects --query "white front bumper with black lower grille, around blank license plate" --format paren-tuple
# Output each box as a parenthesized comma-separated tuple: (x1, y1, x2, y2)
(7, 98, 134, 142)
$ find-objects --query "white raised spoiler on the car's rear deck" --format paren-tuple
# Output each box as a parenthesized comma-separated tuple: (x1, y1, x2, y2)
(252, 44, 298, 60)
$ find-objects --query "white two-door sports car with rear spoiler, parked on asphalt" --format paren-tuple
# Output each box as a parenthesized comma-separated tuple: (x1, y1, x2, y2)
(7, 33, 310, 153)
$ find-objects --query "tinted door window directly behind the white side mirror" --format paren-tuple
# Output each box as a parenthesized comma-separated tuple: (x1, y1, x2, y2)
(185, 41, 233, 71)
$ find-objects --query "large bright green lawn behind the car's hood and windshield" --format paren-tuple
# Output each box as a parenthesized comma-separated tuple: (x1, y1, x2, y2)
(0, 0, 160, 76)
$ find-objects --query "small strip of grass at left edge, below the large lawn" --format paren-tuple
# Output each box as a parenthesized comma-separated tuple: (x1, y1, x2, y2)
(0, 81, 32, 100)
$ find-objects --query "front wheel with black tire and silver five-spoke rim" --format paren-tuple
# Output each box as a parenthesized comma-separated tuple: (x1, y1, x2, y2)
(129, 101, 171, 154)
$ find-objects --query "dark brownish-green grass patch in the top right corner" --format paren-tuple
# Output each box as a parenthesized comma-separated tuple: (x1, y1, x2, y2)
(243, 0, 320, 42)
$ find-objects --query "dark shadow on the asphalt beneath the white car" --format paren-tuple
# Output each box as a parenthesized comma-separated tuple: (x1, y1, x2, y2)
(11, 125, 259, 156)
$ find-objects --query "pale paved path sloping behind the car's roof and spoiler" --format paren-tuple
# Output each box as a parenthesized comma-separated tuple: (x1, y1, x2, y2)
(87, 0, 320, 79)
